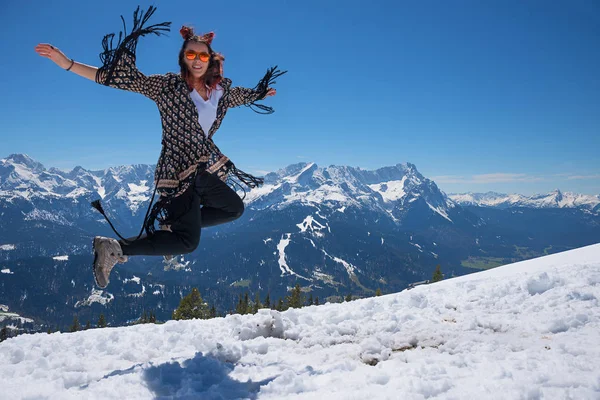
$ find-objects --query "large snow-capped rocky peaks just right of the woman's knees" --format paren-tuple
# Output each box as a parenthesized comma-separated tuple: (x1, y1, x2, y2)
(247, 163, 455, 223)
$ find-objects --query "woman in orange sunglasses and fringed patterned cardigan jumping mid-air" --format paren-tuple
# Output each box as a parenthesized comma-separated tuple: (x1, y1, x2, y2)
(35, 6, 285, 288)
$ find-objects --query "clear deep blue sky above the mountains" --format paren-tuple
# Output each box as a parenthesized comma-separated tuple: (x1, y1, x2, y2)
(0, 0, 600, 194)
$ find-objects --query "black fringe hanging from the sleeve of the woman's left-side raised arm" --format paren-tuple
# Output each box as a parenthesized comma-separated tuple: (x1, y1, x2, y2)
(96, 6, 171, 83)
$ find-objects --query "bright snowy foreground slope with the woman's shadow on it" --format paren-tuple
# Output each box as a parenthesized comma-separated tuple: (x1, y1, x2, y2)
(0, 245, 600, 400)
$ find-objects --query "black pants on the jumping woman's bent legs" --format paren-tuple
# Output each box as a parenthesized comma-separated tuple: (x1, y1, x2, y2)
(119, 172, 244, 256)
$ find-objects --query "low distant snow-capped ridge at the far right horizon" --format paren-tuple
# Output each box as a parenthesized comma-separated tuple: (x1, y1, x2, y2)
(449, 189, 600, 212)
